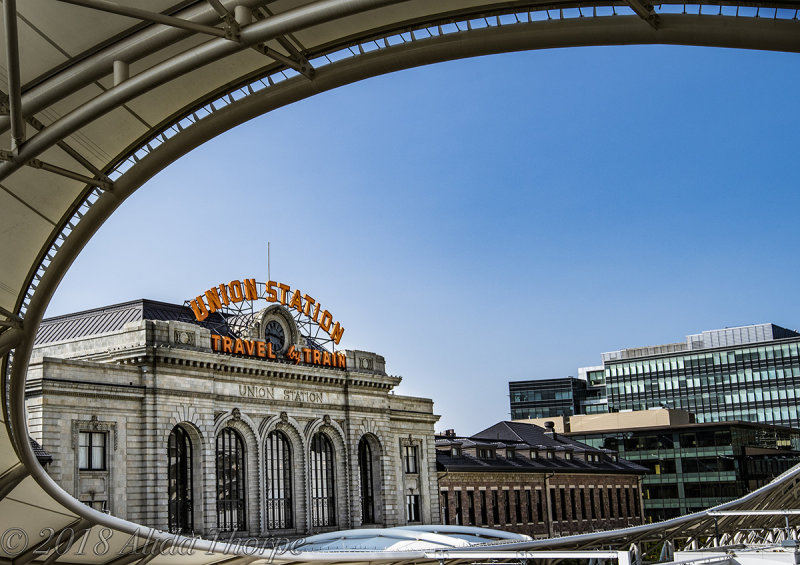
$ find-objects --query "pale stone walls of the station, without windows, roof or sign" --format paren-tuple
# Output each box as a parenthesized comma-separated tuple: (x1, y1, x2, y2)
(27, 304, 440, 537)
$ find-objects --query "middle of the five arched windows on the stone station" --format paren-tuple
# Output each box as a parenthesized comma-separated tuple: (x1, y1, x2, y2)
(264, 430, 293, 530)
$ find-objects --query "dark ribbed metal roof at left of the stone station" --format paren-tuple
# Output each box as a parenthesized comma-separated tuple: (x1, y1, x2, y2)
(34, 298, 230, 345)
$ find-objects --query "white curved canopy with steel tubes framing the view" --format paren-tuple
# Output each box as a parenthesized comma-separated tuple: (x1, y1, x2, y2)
(0, 0, 800, 565)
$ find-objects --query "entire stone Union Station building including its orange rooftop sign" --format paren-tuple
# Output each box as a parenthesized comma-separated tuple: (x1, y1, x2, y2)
(26, 279, 440, 537)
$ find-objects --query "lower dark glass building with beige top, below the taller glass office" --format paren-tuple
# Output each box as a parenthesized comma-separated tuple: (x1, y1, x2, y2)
(516, 409, 800, 522)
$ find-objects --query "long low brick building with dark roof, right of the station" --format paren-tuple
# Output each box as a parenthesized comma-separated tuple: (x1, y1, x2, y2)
(436, 422, 647, 537)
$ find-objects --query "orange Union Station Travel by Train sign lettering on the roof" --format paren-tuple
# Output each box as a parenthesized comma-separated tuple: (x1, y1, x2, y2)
(191, 278, 346, 369)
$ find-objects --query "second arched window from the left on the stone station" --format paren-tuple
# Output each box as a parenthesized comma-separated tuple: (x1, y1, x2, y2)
(217, 428, 247, 532)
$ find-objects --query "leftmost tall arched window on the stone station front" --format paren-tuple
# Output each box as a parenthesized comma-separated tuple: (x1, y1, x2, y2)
(167, 425, 194, 534)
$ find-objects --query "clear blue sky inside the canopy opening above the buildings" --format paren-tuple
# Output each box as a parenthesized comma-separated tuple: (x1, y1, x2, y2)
(48, 46, 800, 434)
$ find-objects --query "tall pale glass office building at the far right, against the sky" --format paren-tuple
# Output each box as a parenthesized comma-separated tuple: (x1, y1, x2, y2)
(604, 324, 800, 427)
